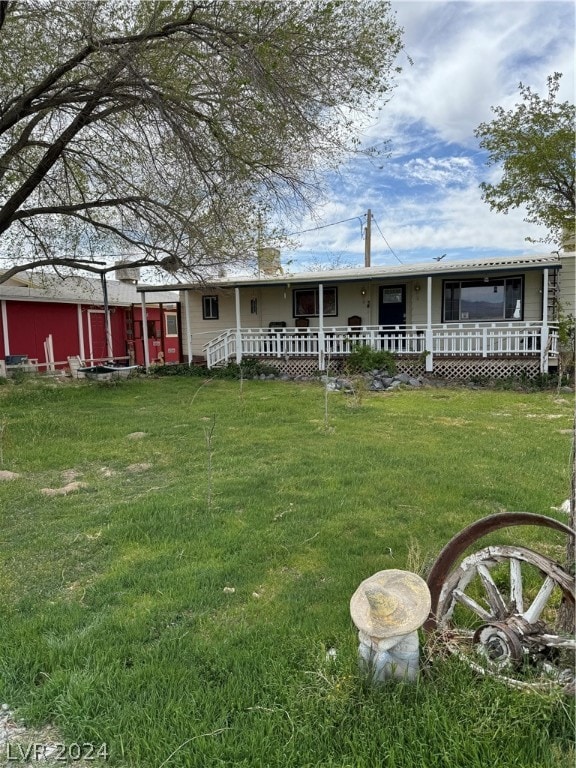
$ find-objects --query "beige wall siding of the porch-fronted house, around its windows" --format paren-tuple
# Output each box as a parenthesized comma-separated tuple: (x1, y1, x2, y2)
(181, 253, 576, 358)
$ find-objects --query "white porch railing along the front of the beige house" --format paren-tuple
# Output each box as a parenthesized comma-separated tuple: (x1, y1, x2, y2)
(204, 322, 558, 371)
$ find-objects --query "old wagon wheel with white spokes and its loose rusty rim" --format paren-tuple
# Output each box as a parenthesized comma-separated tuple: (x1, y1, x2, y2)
(425, 513, 576, 692)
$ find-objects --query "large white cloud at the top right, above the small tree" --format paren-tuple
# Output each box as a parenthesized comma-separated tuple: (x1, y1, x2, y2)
(390, 0, 574, 143)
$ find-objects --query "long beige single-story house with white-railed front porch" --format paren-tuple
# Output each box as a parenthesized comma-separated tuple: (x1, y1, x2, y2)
(137, 252, 576, 378)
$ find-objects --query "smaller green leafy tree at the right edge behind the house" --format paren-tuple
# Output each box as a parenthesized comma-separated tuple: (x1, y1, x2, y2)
(475, 72, 576, 245)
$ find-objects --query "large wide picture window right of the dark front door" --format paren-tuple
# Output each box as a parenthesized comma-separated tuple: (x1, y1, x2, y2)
(443, 277, 523, 322)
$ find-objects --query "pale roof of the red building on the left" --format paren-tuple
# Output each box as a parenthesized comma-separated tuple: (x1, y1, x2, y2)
(0, 273, 179, 307)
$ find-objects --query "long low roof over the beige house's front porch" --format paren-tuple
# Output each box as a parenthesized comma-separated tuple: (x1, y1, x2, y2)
(137, 253, 562, 293)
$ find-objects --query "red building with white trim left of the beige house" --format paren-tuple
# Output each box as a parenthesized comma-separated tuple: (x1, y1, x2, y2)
(0, 268, 182, 373)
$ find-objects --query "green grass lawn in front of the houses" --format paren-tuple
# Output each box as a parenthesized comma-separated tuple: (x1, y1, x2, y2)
(0, 378, 574, 768)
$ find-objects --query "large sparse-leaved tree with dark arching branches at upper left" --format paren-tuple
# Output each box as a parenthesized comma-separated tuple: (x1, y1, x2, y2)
(0, 0, 402, 282)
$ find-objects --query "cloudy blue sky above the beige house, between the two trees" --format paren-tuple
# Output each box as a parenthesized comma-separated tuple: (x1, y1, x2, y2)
(282, 0, 576, 271)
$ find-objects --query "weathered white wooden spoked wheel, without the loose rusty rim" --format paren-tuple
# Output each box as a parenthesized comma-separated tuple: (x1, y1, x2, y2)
(437, 544, 576, 689)
